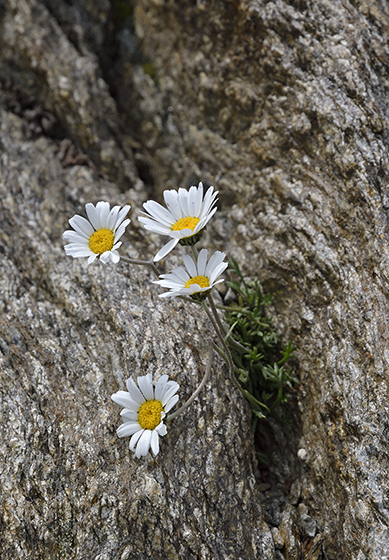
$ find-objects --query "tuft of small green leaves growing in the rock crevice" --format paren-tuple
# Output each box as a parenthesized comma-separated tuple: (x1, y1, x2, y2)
(224, 258, 298, 418)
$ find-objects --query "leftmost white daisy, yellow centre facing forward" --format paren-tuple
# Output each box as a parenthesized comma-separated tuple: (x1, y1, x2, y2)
(63, 202, 131, 264)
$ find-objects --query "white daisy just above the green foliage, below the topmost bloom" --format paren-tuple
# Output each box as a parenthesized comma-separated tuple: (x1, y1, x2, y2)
(154, 249, 228, 299)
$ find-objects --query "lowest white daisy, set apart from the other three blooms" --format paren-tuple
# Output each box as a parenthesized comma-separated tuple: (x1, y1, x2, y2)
(111, 373, 179, 458)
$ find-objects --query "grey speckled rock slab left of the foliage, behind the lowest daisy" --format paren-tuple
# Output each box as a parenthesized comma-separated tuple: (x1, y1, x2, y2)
(0, 106, 273, 560)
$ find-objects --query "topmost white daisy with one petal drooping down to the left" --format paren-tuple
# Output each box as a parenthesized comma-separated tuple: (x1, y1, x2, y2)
(139, 183, 218, 262)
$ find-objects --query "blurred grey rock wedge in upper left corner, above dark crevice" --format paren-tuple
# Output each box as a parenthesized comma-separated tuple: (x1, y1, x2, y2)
(0, 0, 141, 189)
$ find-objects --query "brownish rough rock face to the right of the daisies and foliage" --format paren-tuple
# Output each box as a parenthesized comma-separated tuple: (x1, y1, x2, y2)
(131, 0, 389, 560)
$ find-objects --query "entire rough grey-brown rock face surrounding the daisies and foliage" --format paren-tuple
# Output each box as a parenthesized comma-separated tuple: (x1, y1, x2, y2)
(0, 0, 389, 560)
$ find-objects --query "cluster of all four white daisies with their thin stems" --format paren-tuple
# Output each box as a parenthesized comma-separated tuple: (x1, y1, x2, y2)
(63, 183, 228, 458)
